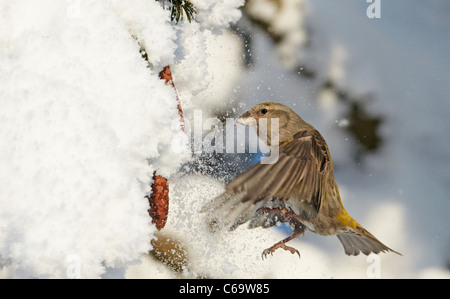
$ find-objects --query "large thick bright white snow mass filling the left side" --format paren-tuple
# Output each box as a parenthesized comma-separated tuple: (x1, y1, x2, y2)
(0, 0, 242, 278)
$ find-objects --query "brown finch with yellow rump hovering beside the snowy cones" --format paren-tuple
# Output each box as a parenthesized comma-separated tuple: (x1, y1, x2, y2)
(201, 102, 401, 259)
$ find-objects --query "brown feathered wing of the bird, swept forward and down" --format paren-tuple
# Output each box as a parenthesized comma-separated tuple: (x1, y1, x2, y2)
(203, 130, 334, 230)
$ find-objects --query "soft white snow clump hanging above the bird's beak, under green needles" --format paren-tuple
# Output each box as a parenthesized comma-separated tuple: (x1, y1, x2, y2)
(173, 0, 245, 118)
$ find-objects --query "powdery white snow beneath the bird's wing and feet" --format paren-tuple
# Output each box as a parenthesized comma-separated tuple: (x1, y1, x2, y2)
(147, 175, 336, 278)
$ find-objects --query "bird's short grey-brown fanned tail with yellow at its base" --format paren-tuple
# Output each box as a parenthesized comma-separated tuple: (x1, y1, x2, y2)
(337, 221, 402, 255)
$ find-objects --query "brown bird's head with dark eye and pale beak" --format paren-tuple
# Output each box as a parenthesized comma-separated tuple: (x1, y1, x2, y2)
(236, 102, 311, 146)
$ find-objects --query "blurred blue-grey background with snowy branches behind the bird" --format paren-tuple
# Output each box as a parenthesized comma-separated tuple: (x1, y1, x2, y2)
(132, 0, 450, 278)
